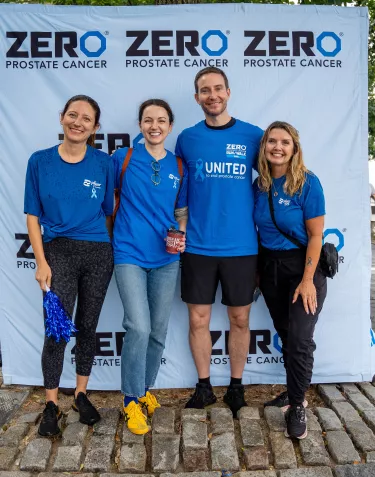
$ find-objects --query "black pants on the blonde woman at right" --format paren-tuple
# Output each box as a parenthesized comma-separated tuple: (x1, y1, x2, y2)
(259, 248, 327, 405)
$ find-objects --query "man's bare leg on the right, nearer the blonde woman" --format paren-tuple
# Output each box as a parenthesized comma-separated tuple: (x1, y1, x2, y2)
(228, 305, 251, 378)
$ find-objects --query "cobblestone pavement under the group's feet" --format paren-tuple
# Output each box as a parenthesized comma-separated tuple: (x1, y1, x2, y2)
(0, 383, 375, 477)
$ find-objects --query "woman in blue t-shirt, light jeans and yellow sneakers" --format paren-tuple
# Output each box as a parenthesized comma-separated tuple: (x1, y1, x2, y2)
(113, 99, 187, 434)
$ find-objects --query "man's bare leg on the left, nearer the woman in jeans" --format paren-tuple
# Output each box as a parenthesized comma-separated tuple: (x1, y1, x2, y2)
(188, 304, 212, 378)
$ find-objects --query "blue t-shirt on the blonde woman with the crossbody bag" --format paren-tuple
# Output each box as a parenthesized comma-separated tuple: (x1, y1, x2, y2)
(254, 172, 326, 250)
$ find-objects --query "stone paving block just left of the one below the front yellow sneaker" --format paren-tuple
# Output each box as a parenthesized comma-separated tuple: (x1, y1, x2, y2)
(84, 436, 115, 472)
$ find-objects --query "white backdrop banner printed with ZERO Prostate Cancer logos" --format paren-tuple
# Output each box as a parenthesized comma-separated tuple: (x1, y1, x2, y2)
(0, 4, 375, 389)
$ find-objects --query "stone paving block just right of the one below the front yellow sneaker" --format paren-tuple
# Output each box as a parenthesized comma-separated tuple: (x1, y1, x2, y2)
(151, 434, 180, 472)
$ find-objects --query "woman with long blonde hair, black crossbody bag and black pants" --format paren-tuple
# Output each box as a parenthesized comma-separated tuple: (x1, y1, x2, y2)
(254, 121, 327, 439)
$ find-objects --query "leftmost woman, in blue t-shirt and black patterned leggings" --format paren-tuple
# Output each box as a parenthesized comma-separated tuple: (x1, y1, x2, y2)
(24, 95, 114, 436)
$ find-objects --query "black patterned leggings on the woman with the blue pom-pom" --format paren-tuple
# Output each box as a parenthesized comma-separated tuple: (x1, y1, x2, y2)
(42, 238, 113, 389)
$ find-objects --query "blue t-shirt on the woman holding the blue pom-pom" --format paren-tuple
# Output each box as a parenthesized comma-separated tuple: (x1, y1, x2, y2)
(24, 146, 114, 242)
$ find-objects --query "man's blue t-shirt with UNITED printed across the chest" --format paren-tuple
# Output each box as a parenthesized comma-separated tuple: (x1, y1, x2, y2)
(176, 119, 263, 257)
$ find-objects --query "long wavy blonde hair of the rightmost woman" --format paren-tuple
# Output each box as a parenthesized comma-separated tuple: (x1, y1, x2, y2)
(258, 121, 308, 196)
